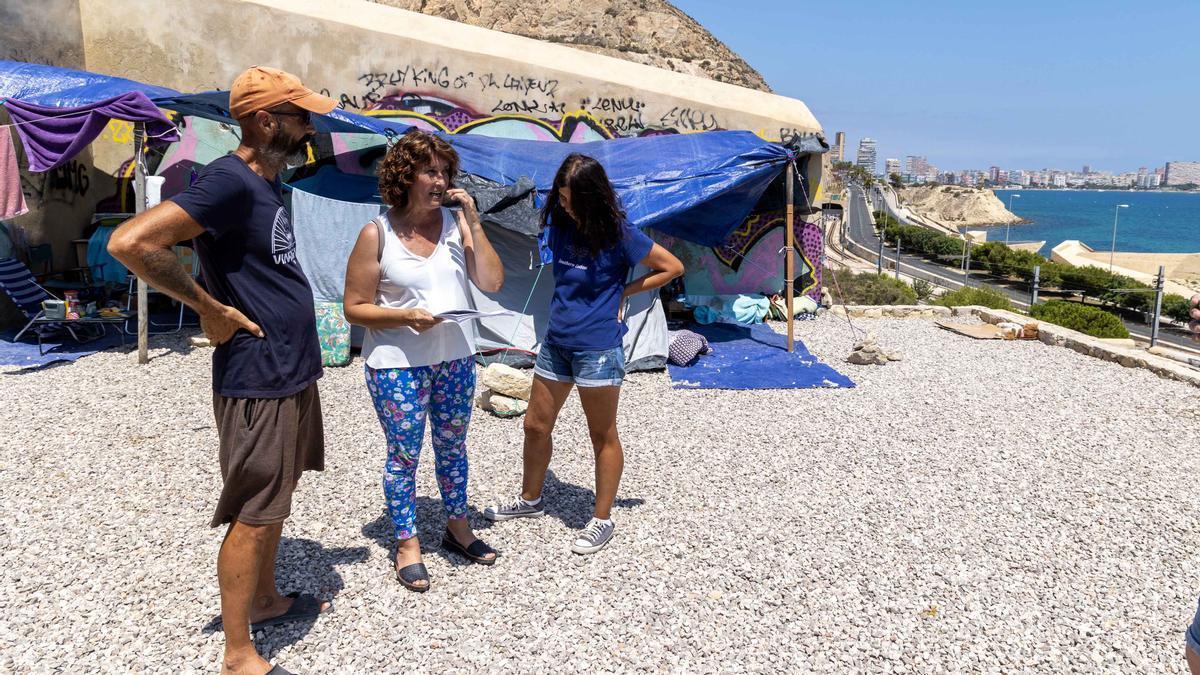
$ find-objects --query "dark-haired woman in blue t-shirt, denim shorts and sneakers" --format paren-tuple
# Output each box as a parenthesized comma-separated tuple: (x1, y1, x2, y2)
(484, 154, 683, 554)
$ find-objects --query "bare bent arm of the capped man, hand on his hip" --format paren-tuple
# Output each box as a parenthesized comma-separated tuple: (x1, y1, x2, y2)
(108, 202, 263, 345)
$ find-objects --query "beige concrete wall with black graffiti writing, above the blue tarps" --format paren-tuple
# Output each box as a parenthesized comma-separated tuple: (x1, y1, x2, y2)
(79, 0, 821, 139)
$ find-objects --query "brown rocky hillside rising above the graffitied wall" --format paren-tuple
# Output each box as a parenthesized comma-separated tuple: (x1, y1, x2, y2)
(364, 0, 770, 91)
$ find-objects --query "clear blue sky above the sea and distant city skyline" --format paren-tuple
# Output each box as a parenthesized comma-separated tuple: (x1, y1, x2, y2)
(671, 0, 1200, 172)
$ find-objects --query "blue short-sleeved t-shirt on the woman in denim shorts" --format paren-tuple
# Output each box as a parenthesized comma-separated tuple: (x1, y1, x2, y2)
(544, 223, 654, 350)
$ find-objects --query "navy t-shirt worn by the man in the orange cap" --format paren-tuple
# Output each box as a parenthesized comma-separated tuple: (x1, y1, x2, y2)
(172, 155, 322, 399)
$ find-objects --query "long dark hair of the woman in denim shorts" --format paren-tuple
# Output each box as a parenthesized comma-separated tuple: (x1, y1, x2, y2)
(541, 153, 625, 255)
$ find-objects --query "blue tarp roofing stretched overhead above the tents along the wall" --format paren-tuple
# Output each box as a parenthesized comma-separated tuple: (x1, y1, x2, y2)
(0, 61, 792, 246)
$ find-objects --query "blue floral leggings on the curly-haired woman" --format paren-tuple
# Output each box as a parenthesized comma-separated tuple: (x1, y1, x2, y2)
(366, 357, 475, 539)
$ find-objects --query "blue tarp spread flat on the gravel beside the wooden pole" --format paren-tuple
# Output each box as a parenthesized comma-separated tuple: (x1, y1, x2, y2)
(667, 323, 854, 389)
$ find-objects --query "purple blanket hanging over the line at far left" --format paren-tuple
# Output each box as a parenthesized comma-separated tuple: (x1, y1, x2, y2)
(4, 91, 179, 172)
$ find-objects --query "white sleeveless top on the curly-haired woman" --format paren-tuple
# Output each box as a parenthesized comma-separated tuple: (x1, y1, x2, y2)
(362, 208, 475, 370)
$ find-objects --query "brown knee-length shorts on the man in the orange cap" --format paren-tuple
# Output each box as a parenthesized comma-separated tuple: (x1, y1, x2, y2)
(212, 382, 325, 527)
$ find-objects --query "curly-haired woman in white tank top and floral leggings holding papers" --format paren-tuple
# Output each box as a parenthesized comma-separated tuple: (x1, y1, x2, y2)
(344, 131, 504, 592)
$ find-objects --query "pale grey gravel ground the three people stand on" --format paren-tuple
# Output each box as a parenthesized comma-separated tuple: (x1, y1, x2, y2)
(0, 316, 1200, 673)
